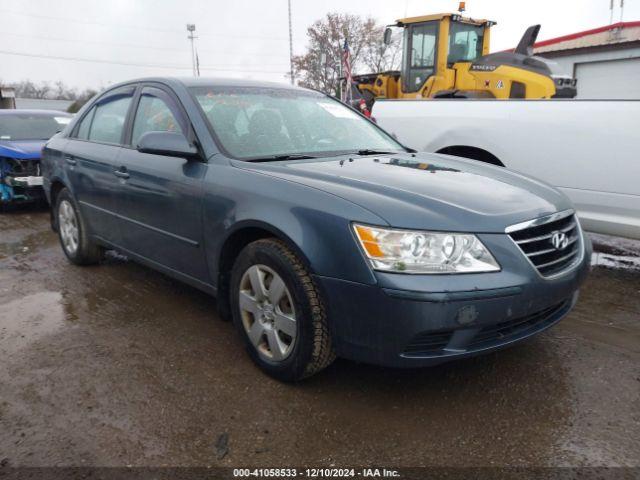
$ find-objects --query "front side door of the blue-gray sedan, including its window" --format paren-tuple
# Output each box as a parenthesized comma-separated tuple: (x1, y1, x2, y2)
(112, 86, 209, 282)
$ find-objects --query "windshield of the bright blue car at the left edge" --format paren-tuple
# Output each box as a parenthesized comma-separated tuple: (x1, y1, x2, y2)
(0, 112, 71, 140)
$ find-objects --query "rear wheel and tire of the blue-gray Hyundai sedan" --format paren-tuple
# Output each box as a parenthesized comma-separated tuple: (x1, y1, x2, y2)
(54, 188, 103, 265)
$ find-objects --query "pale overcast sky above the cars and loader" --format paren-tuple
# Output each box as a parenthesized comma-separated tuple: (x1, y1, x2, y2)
(0, 0, 640, 88)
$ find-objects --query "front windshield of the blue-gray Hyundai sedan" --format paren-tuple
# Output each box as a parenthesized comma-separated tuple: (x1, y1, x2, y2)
(192, 87, 404, 160)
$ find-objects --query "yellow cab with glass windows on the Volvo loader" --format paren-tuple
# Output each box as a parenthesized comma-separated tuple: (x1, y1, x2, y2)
(385, 14, 493, 98)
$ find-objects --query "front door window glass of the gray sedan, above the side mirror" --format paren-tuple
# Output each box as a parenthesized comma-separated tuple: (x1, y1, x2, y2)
(131, 92, 186, 147)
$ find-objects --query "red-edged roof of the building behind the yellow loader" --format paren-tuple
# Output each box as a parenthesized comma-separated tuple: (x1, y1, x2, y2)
(534, 22, 640, 54)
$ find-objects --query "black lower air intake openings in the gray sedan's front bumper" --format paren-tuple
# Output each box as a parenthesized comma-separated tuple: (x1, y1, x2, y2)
(402, 300, 571, 357)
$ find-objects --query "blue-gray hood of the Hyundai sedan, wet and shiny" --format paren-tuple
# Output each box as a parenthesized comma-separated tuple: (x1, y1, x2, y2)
(236, 154, 572, 233)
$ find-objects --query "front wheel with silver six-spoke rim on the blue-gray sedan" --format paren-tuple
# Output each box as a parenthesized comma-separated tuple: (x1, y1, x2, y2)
(230, 239, 335, 382)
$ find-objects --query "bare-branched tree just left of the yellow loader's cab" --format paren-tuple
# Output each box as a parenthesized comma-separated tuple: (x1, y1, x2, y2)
(294, 13, 390, 95)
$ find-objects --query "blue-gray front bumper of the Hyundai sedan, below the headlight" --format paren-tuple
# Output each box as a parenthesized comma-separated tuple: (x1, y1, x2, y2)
(315, 235, 591, 367)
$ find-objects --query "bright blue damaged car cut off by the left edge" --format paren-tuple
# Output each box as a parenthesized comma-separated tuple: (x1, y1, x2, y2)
(0, 110, 71, 206)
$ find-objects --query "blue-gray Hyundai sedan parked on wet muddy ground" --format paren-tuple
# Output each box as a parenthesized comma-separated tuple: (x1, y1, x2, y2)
(42, 78, 591, 381)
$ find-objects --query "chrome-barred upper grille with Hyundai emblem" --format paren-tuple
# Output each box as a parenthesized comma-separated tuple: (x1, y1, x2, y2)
(507, 211, 582, 277)
